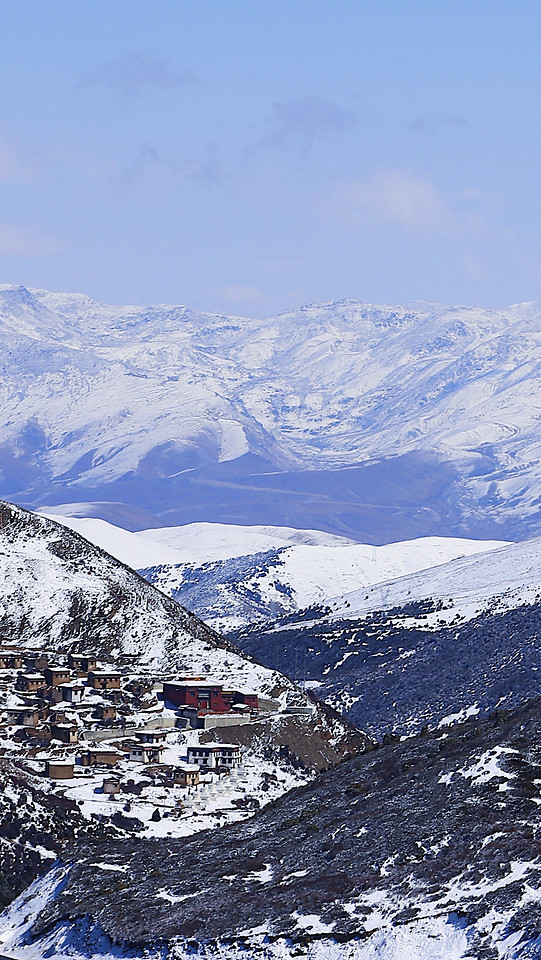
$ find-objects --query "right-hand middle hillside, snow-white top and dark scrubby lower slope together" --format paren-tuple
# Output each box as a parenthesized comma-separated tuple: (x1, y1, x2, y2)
(230, 540, 541, 737)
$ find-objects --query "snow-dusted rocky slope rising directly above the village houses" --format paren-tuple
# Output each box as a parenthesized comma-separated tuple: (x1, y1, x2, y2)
(0, 503, 288, 690)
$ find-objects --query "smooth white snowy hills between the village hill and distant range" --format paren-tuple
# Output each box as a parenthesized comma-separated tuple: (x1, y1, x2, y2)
(39, 515, 501, 632)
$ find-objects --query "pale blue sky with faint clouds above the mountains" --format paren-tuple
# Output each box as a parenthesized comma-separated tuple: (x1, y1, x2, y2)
(0, 0, 541, 317)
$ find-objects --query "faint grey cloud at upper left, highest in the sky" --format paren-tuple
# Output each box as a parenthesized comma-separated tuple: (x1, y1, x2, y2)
(78, 53, 195, 100)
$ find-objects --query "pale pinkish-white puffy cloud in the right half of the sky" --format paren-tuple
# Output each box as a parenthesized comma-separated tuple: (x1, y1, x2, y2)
(329, 170, 459, 233)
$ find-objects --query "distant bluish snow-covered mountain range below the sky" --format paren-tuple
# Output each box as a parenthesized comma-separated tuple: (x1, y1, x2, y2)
(0, 287, 541, 543)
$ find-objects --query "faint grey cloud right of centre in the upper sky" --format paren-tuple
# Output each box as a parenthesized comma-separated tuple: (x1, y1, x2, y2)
(255, 97, 355, 150)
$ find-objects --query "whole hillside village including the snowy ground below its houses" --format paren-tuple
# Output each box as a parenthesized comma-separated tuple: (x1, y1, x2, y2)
(0, 641, 308, 836)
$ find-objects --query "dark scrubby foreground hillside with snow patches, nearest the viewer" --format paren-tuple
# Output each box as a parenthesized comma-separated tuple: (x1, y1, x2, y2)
(5, 698, 541, 960)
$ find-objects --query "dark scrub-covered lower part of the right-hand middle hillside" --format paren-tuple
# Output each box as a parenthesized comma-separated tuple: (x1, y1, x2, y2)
(233, 596, 541, 737)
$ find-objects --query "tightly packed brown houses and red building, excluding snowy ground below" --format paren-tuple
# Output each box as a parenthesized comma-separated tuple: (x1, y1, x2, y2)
(0, 643, 256, 794)
